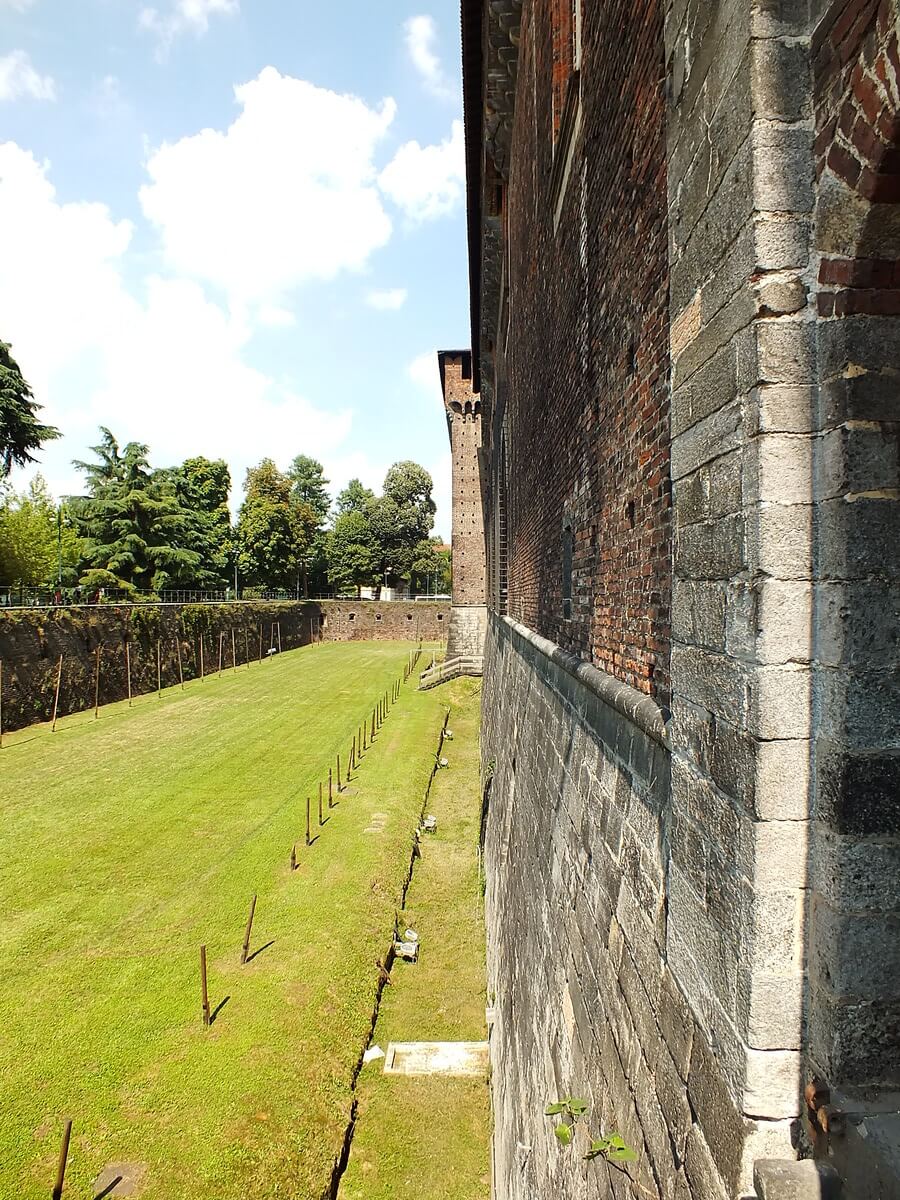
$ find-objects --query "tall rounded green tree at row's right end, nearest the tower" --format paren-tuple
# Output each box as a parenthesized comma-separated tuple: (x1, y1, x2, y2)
(371, 461, 434, 582)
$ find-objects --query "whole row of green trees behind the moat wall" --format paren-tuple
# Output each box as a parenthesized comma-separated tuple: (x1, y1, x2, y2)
(0, 342, 450, 595)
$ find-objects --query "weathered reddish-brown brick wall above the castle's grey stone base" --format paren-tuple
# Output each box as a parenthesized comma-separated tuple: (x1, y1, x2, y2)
(497, 0, 670, 703)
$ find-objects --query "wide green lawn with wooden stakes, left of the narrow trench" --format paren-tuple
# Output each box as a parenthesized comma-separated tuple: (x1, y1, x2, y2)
(0, 642, 458, 1200)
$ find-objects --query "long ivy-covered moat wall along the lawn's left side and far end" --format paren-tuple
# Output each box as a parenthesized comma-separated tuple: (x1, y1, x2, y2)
(0, 601, 450, 730)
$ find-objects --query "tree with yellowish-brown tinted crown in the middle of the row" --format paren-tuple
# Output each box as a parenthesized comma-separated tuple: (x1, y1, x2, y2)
(236, 458, 317, 588)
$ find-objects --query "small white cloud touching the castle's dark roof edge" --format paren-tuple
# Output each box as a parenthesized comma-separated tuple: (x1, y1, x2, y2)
(378, 121, 466, 222)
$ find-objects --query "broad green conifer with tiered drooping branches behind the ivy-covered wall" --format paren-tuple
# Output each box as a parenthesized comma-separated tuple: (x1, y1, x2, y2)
(70, 427, 200, 592)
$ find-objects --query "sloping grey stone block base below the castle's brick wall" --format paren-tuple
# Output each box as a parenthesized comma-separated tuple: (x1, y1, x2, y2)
(481, 616, 752, 1200)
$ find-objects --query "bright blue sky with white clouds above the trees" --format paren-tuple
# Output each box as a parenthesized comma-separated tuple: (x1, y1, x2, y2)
(0, 0, 469, 539)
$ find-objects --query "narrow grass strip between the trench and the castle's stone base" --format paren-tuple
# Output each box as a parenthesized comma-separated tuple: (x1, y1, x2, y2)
(340, 681, 491, 1200)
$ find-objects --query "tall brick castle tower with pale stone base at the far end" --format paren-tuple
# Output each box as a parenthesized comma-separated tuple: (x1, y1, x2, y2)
(438, 350, 487, 668)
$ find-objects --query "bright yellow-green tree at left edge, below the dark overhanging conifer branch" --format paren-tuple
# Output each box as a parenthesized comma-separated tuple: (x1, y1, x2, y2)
(0, 475, 79, 587)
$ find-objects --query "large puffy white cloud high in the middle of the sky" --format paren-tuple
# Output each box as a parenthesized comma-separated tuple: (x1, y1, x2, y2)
(140, 67, 396, 305)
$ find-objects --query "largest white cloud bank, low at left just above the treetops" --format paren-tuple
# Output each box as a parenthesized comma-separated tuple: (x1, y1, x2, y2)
(0, 143, 352, 506)
